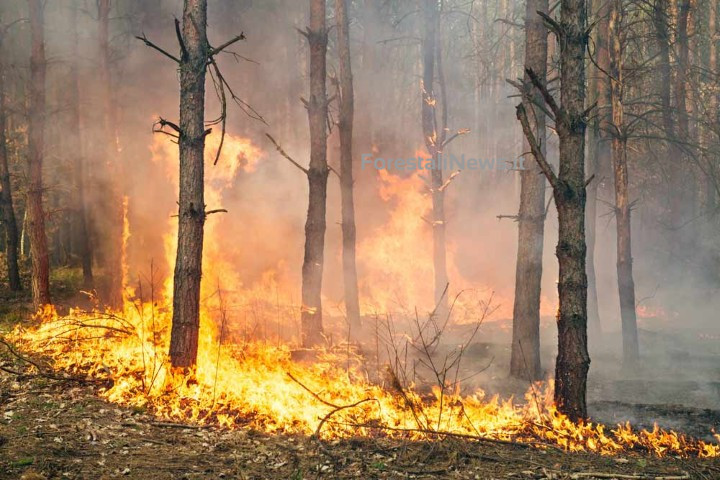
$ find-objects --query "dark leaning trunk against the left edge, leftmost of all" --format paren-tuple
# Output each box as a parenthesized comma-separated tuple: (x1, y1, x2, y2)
(0, 32, 22, 292)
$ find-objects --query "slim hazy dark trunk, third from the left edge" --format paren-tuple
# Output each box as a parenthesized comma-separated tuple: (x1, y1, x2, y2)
(67, 5, 93, 289)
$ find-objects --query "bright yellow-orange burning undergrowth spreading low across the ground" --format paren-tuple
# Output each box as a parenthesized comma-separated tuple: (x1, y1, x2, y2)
(2, 302, 720, 457)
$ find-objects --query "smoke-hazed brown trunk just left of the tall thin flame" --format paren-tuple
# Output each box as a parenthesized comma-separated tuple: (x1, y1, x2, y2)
(96, 0, 123, 308)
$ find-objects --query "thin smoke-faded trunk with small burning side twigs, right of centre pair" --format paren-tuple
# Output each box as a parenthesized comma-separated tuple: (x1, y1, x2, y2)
(422, 0, 448, 313)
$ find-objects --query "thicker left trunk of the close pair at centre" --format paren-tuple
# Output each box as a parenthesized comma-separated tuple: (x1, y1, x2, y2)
(301, 0, 328, 347)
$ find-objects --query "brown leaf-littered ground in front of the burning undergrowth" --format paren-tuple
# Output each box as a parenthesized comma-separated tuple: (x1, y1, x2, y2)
(0, 272, 720, 480)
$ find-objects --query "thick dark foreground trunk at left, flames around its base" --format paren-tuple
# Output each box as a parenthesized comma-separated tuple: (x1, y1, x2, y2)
(170, 0, 209, 368)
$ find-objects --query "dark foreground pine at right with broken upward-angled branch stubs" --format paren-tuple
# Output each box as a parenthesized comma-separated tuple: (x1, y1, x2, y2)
(517, 0, 590, 420)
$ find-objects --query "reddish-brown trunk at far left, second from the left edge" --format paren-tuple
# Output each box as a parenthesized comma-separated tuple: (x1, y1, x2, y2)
(27, 0, 51, 308)
